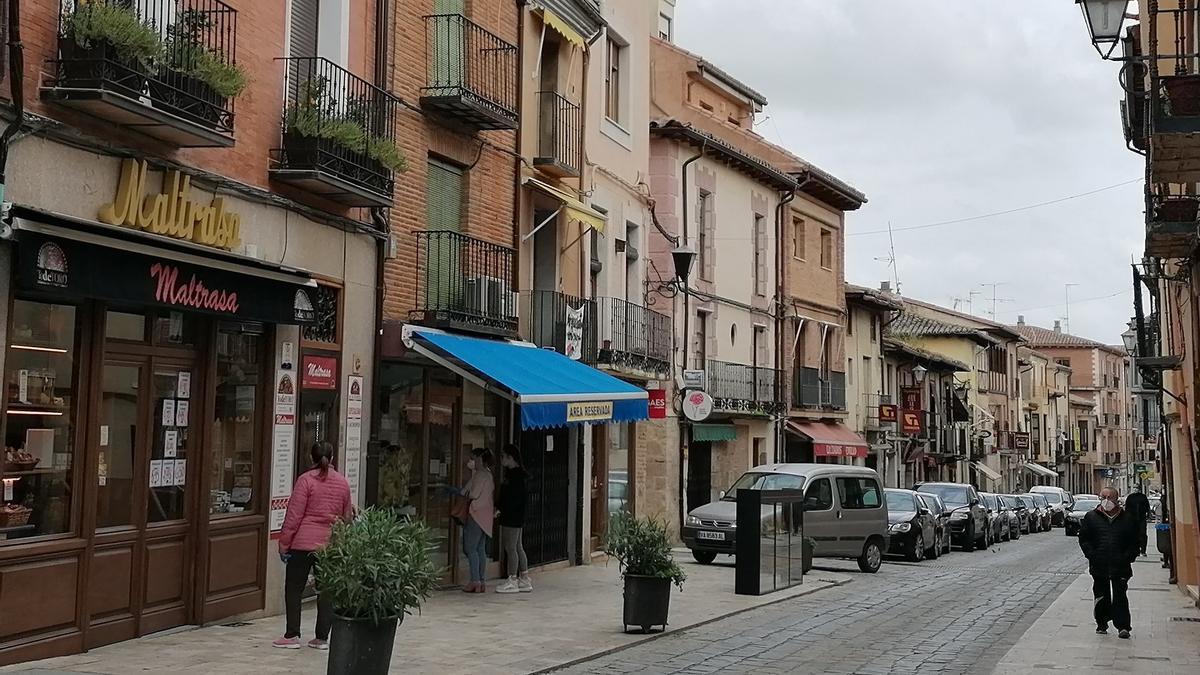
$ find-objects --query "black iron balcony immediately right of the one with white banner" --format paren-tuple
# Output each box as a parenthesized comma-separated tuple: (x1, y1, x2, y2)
(598, 298, 671, 378)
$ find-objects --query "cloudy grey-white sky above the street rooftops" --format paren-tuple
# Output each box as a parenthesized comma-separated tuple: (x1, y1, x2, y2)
(676, 0, 1145, 345)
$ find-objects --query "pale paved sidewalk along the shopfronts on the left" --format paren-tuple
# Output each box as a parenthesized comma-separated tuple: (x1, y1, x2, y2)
(0, 550, 853, 675)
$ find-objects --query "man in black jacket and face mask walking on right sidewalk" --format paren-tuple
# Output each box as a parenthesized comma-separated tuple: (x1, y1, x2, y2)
(1079, 488, 1146, 639)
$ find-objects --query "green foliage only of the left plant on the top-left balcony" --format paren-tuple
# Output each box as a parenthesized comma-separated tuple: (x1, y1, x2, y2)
(64, 2, 163, 70)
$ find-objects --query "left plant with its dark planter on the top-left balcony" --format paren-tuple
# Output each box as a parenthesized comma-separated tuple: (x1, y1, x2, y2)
(59, 1, 162, 96)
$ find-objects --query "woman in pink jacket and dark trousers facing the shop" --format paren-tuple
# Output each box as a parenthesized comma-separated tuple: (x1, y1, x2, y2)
(271, 442, 354, 650)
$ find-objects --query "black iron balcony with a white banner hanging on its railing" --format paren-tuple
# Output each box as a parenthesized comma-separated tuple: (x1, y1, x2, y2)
(521, 291, 598, 364)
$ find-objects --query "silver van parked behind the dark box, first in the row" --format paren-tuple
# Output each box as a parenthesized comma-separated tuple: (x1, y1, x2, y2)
(683, 464, 888, 573)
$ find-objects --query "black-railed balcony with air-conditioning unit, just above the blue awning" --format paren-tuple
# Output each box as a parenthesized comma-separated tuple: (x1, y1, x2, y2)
(409, 232, 518, 338)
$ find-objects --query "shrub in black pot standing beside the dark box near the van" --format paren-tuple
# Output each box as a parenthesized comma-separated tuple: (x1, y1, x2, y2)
(605, 514, 688, 633)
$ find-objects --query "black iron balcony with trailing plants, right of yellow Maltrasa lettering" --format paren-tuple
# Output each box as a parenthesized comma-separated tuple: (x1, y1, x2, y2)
(270, 56, 406, 207)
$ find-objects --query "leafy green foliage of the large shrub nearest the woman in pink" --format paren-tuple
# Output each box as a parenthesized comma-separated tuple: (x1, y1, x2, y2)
(316, 508, 442, 623)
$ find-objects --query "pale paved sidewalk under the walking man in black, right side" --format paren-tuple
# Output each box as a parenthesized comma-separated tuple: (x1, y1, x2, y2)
(994, 555, 1200, 675)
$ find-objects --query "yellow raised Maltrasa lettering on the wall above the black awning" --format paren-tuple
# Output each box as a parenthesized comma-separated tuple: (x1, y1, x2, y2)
(96, 160, 241, 251)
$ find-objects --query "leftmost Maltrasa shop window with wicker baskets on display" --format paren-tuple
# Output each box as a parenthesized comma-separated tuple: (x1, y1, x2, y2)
(0, 300, 77, 545)
